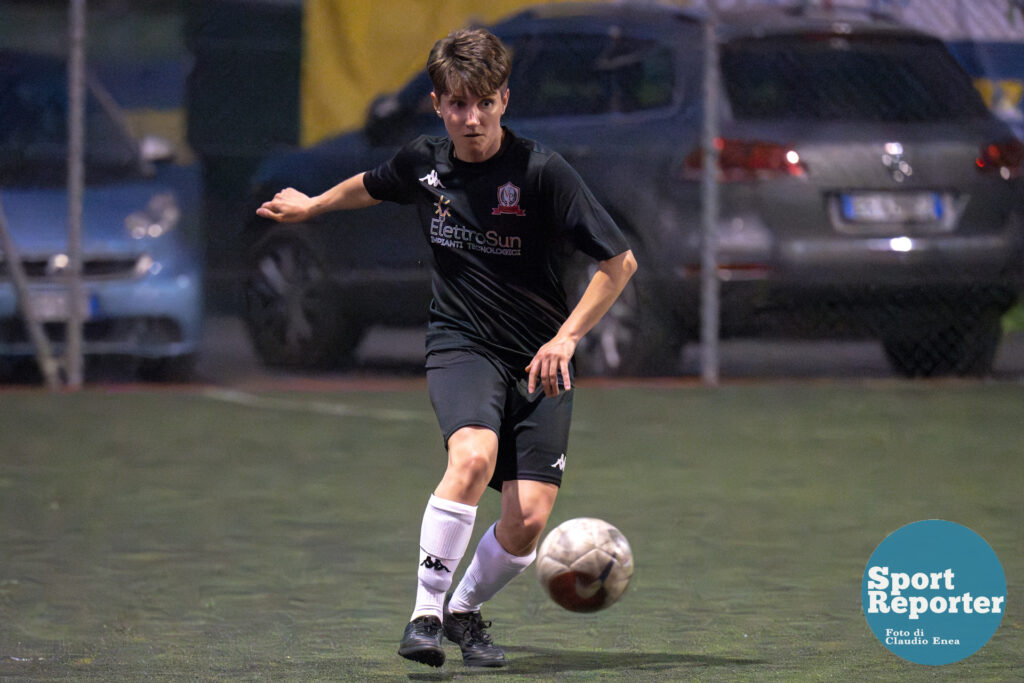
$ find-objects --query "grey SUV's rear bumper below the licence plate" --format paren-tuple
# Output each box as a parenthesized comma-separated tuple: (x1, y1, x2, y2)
(658, 234, 1024, 338)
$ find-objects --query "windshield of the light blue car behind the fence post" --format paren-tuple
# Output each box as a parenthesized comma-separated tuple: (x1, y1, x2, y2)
(0, 60, 140, 186)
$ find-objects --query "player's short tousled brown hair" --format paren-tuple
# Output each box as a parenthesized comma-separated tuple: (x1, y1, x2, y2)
(427, 29, 512, 97)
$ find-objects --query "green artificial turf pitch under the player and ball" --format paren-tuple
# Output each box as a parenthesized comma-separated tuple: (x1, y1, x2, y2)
(0, 381, 1024, 681)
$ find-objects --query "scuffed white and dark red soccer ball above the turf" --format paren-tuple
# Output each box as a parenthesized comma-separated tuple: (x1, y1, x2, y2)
(537, 517, 633, 612)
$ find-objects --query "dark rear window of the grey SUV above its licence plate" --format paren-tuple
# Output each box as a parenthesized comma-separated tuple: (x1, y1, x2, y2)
(721, 34, 986, 122)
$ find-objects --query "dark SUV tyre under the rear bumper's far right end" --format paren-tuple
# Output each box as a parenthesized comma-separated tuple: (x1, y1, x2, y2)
(883, 313, 1002, 377)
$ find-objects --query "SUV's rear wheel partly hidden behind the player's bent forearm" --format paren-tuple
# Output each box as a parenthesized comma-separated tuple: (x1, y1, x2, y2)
(569, 264, 682, 377)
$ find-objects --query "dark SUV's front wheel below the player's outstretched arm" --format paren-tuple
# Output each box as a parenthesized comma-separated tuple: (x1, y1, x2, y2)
(245, 232, 362, 369)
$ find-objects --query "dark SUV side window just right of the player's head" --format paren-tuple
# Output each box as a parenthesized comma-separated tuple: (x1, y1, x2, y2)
(509, 34, 675, 118)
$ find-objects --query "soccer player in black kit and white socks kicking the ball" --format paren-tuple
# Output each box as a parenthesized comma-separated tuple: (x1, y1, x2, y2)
(257, 30, 636, 667)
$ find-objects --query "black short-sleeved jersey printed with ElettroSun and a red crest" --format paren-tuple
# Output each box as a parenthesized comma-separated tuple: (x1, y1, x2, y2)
(364, 129, 629, 375)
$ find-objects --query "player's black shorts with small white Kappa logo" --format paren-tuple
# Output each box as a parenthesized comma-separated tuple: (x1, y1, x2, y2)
(427, 349, 573, 490)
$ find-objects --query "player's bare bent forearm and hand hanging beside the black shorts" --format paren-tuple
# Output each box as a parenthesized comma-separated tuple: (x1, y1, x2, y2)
(526, 250, 637, 396)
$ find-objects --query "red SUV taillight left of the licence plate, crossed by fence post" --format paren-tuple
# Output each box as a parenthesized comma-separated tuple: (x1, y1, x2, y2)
(684, 137, 807, 182)
